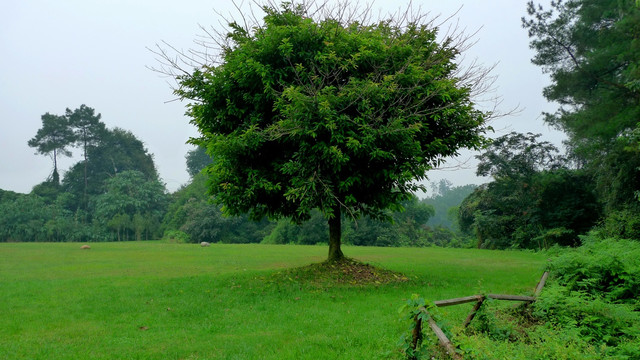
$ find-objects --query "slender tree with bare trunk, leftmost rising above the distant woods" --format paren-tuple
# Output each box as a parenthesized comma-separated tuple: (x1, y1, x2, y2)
(28, 113, 75, 185)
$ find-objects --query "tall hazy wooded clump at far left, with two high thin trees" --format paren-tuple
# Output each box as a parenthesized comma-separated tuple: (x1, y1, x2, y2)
(0, 105, 167, 241)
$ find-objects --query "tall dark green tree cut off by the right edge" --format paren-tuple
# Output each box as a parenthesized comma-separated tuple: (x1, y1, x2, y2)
(522, 0, 640, 212)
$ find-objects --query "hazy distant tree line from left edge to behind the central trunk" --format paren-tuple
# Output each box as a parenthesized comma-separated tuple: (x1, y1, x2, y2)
(0, 109, 450, 246)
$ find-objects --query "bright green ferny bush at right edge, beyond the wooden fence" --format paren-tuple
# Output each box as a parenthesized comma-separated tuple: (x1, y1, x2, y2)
(533, 238, 640, 359)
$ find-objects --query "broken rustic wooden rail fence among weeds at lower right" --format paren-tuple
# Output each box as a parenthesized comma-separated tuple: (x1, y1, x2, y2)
(411, 271, 549, 360)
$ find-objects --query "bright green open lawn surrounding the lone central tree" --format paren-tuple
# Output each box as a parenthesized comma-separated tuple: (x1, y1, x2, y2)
(0, 242, 545, 359)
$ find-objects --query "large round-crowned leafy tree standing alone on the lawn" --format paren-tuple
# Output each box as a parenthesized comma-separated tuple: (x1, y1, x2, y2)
(159, 2, 489, 261)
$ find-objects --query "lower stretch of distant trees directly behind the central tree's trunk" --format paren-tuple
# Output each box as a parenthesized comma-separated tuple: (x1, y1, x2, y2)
(163, 174, 451, 246)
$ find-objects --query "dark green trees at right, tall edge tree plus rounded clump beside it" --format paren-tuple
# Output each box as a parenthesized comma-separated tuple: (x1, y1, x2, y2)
(459, 0, 640, 248)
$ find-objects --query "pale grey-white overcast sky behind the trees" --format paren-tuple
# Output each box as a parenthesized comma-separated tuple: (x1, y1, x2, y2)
(0, 0, 563, 197)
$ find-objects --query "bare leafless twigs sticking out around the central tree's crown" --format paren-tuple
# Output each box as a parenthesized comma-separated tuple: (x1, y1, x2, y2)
(149, 0, 504, 117)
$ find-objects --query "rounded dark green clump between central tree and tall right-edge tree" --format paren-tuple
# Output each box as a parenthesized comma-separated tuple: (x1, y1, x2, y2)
(458, 133, 600, 249)
